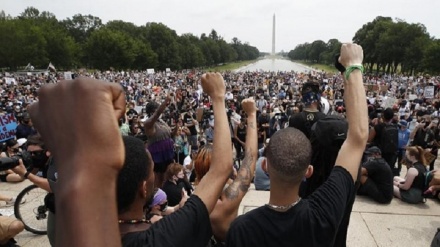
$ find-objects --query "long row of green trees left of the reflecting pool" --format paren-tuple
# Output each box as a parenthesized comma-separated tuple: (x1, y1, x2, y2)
(0, 7, 260, 70)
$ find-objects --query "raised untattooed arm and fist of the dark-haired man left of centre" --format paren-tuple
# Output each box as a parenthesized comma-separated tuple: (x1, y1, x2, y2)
(194, 73, 232, 213)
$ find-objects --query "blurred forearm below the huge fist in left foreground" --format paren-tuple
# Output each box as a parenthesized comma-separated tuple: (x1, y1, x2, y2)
(55, 167, 121, 246)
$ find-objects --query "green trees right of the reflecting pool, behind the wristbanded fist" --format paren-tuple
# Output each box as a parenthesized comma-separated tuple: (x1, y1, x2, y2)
(288, 16, 440, 74)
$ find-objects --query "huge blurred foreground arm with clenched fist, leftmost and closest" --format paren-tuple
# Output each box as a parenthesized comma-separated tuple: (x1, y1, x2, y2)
(29, 78, 125, 247)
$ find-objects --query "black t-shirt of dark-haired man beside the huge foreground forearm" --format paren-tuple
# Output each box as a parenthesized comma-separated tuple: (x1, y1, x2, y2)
(122, 195, 212, 247)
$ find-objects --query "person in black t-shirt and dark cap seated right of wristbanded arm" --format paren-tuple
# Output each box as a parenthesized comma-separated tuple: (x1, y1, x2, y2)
(357, 147, 393, 203)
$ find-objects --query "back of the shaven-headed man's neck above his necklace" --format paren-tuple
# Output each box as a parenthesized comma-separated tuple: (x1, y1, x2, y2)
(269, 180, 299, 206)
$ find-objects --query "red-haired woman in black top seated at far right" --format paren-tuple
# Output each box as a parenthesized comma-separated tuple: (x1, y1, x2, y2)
(393, 146, 427, 203)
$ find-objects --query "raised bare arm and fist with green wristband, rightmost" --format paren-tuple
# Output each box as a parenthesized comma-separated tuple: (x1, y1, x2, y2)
(335, 44, 368, 181)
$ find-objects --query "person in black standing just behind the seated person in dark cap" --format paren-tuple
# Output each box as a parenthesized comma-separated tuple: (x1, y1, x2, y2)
(368, 108, 399, 176)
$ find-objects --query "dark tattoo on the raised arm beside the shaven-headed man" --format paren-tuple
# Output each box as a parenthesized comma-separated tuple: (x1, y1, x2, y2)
(225, 148, 255, 200)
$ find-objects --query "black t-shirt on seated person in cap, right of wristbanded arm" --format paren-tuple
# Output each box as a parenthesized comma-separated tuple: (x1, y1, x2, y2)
(362, 158, 394, 197)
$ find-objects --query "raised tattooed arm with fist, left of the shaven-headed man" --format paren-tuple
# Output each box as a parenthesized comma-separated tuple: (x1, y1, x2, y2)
(210, 99, 258, 240)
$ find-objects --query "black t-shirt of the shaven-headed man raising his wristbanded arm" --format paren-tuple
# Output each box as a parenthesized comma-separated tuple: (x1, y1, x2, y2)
(226, 166, 355, 247)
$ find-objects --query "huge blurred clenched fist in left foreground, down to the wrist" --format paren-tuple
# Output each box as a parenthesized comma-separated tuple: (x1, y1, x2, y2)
(29, 78, 125, 178)
